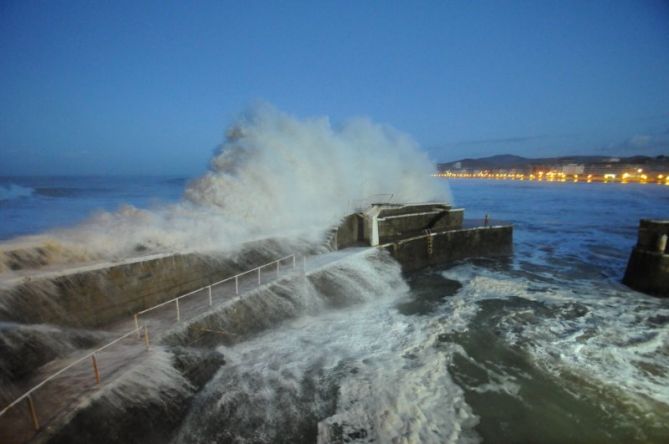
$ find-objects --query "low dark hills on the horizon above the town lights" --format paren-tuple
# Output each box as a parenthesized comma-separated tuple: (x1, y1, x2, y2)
(438, 154, 669, 171)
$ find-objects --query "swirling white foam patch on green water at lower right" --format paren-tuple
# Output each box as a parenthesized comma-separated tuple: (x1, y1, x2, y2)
(444, 265, 669, 411)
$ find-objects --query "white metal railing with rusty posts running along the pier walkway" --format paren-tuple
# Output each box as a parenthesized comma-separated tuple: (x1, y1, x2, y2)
(0, 254, 296, 442)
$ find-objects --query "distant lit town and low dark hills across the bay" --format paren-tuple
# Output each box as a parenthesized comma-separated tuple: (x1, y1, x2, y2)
(435, 154, 669, 186)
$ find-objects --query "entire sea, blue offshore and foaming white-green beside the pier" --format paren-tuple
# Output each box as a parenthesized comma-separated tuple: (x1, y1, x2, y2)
(0, 177, 669, 443)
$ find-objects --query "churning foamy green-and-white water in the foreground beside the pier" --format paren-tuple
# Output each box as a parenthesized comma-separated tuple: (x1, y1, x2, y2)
(174, 210, 669, 443)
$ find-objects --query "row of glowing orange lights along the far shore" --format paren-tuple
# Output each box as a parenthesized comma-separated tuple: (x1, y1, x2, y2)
(434, 168, 669, 186)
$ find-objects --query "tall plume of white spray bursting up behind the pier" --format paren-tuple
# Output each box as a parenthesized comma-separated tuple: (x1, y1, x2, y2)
(186, 107, 444, 229)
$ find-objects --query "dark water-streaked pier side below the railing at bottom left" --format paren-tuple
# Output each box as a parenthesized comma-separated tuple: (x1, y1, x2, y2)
(40, 345, 202, 444)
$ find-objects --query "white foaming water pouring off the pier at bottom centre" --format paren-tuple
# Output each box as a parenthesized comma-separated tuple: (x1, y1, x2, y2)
(175, 253, 477, 443)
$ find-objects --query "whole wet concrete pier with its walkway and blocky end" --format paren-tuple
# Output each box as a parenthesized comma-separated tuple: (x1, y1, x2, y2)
(0, 203, 513, 443)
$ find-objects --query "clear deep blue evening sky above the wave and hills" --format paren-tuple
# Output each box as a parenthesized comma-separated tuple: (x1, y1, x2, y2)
(0, 0, 669, 175)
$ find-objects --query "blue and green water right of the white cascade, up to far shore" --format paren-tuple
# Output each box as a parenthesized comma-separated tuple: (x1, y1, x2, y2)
(436, 181, 669, 443)
